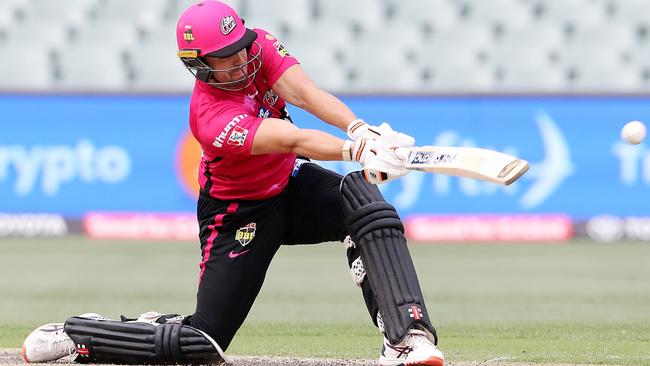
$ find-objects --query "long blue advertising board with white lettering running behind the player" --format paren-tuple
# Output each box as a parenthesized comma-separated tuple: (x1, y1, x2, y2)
(0, 96, 650, 219)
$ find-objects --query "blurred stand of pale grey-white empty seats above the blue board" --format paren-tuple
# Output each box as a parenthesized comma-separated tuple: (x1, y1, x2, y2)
(0, 0, 650, 93)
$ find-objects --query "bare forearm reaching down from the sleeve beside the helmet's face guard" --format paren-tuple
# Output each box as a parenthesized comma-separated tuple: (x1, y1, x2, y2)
(273, 65, 357, 132)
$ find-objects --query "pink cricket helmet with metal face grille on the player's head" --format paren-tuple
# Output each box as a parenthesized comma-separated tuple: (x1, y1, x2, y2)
(176, 0, 262, 91)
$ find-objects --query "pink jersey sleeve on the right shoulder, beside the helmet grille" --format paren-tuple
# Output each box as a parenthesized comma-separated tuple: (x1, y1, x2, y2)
(255, 29, 299, 86)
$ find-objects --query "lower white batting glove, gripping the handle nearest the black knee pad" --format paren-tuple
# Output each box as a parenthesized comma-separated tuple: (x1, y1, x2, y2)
(342, 138, 409, 184)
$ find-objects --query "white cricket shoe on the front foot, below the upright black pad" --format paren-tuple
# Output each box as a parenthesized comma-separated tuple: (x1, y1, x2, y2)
(379, 329, 445, 366)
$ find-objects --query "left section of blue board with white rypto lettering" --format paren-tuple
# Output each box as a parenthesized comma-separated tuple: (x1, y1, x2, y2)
(0, 96, 194, 216)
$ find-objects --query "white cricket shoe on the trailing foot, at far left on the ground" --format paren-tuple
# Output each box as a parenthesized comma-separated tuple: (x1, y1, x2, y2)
(21, 313, 105, 363)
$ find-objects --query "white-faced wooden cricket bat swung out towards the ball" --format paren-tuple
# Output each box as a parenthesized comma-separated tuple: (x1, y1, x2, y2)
(395, 146, 528, 186)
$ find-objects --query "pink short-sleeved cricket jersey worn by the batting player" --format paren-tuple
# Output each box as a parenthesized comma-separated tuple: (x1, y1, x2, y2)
(190, 29, 298, 200)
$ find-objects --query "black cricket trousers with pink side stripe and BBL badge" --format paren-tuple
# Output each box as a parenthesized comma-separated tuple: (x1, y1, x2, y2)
(186, 162, 378, 350)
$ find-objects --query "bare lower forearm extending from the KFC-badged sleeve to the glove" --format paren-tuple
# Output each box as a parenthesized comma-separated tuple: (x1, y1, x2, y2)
(251, 118, 345, 160)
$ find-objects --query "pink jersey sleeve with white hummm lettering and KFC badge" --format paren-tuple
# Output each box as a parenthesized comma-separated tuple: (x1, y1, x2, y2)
(196, 108, 263, 157)
